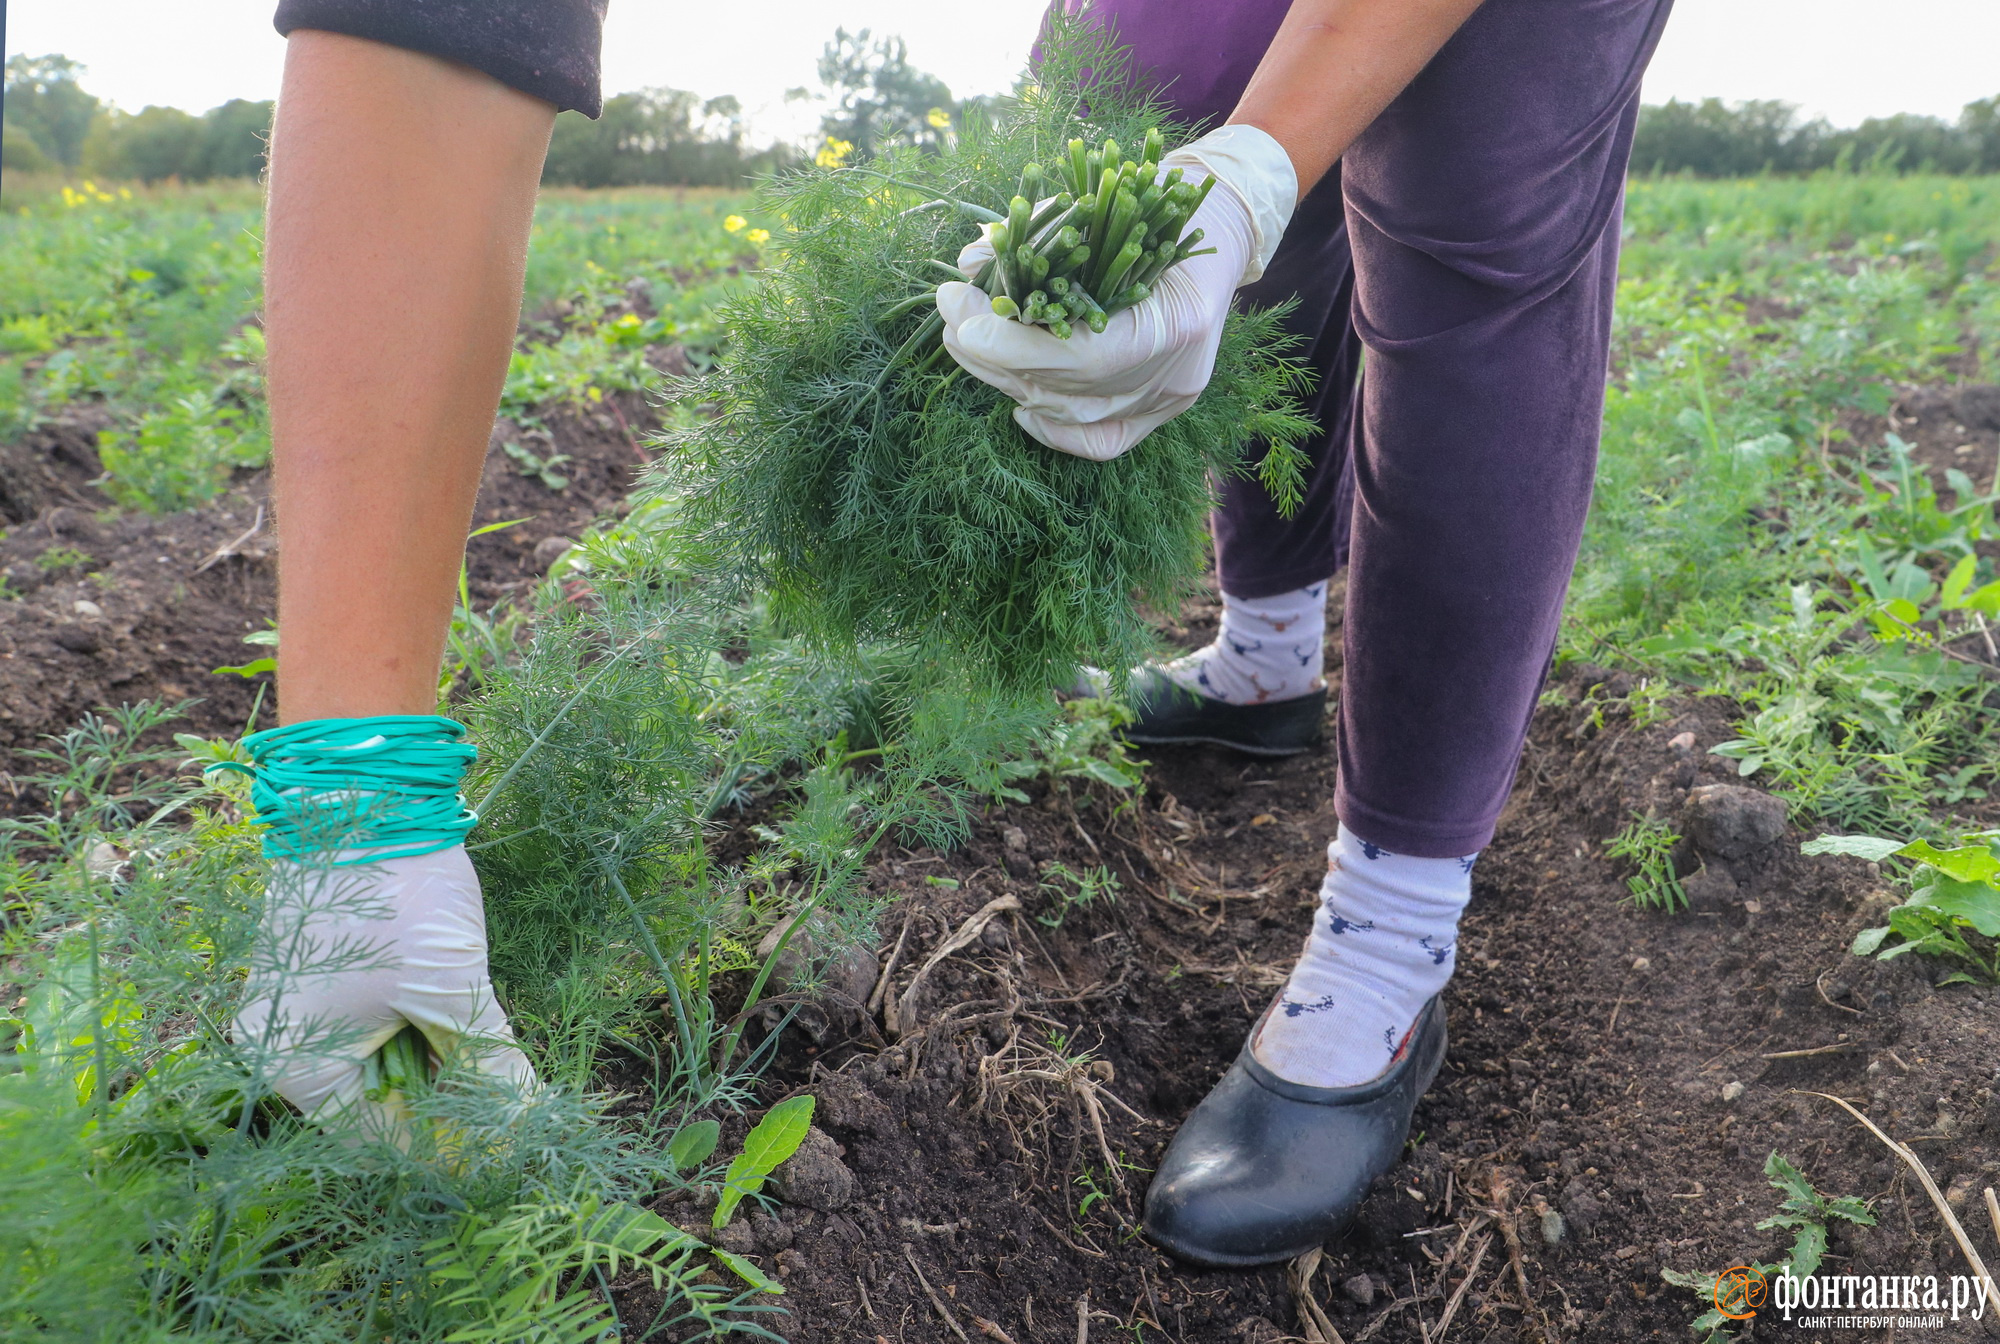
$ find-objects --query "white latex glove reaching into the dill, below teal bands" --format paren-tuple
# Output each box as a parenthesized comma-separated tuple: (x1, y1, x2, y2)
(236, 844, 534, 1120)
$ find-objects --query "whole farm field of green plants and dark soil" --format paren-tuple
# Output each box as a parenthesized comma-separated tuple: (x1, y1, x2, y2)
(0, 176, 2000, 1344)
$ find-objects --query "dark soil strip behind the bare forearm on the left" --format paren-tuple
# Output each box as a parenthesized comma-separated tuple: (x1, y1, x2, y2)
(0, 394, 656, 776)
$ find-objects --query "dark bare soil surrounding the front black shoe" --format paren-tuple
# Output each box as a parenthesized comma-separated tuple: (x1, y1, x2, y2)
(688, 648, 2000, 1344)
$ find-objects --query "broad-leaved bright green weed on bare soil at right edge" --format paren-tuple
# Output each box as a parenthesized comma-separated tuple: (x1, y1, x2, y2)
(1802, 832, 2000, 984)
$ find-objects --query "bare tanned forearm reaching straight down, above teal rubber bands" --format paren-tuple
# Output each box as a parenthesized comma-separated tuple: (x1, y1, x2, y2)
(264, 30, 554, 722)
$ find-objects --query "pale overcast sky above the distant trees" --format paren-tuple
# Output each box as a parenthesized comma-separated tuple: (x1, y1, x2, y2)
(4, 0, 2000, 134)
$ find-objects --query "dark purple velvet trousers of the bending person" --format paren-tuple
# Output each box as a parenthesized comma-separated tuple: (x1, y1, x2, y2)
(1098, 0, 1670, 858)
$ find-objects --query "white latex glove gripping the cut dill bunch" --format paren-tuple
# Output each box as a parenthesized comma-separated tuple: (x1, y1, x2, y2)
(938, 126, 1298, 462)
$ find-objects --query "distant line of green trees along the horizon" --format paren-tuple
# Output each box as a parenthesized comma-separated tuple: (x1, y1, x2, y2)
(0, 46, 2000, 186)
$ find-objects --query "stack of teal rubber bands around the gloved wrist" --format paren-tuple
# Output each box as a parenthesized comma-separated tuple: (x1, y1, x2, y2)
(210, 714, 480, 868)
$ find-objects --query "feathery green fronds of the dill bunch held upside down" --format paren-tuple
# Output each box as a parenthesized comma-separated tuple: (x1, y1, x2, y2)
(650, 20, 1310, 690)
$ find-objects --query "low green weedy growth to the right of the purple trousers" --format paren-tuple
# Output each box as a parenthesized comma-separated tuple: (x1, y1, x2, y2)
(1564, 176, 2000, 830)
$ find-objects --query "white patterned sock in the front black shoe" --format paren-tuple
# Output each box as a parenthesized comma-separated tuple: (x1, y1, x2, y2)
(1250, 828, 1478, 1088)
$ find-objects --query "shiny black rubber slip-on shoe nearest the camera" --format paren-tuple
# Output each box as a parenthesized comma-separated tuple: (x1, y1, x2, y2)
(1144, 998, 1444, 1268)
